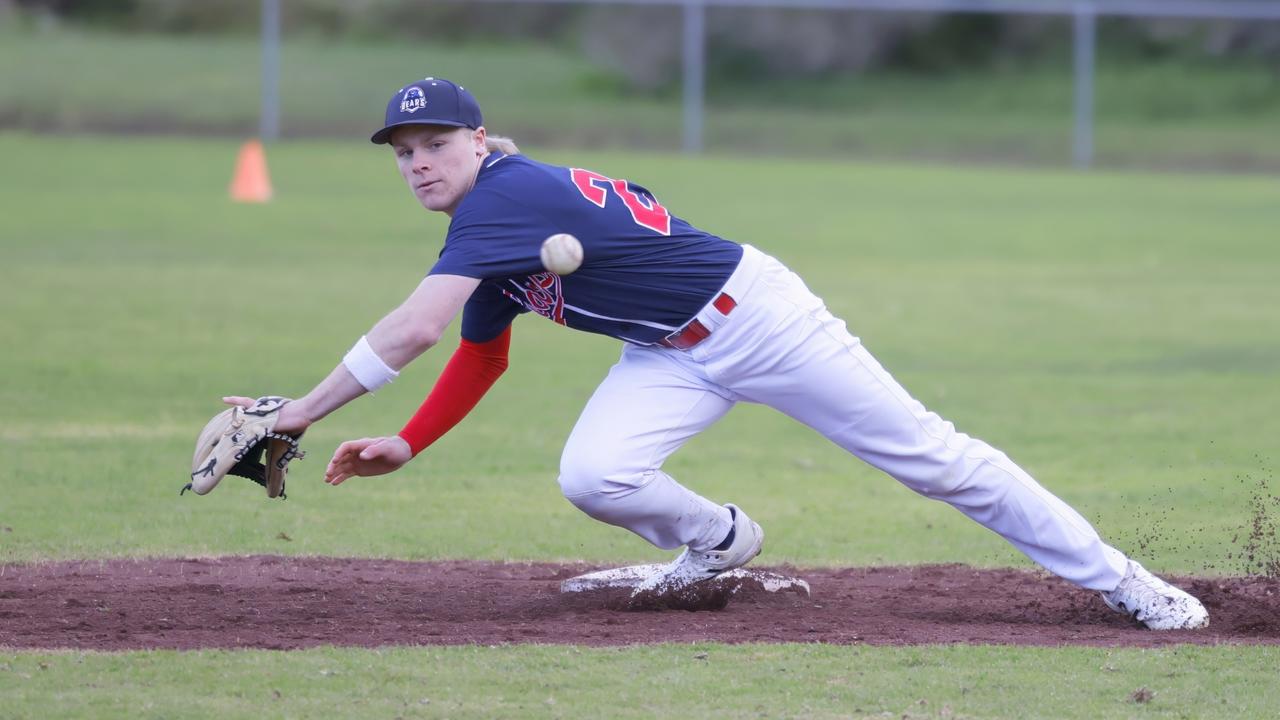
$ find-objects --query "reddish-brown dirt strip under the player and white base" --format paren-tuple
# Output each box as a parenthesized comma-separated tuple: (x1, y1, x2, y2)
(0, 556, 1280, 650)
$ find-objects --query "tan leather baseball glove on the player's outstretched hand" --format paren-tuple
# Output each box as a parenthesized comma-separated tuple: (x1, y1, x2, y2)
(178, 395, 303, 498)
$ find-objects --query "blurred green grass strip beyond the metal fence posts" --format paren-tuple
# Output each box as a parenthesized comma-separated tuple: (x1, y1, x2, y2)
(0, 26, 1280, 170)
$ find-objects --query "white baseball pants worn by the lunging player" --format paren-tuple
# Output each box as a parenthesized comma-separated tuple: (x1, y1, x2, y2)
(559, 246, 1126, 591)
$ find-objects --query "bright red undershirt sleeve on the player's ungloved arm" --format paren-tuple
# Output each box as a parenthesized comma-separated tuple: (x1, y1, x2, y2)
(399, 325, 511, 456)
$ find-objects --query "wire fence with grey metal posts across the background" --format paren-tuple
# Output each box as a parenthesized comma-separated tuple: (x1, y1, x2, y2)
(0, 0, 1280, 170)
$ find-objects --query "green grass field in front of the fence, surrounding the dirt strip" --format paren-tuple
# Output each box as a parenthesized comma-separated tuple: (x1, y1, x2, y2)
(0, 133, 1280, 717)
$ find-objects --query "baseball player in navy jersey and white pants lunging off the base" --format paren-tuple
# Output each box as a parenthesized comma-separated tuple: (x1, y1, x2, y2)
(225, 78, 1208, 629)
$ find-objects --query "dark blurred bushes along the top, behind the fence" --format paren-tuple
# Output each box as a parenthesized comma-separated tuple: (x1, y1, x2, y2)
(12, 0, 1280, 92)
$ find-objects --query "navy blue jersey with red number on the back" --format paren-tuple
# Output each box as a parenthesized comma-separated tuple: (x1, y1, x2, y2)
(431, 152, 742, 345)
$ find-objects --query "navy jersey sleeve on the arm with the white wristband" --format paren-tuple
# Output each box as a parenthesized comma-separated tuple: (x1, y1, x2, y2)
(429, 188, 552, 279)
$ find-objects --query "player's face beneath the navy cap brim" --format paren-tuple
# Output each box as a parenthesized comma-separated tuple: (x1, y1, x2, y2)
(392, 126, 485, 217)
